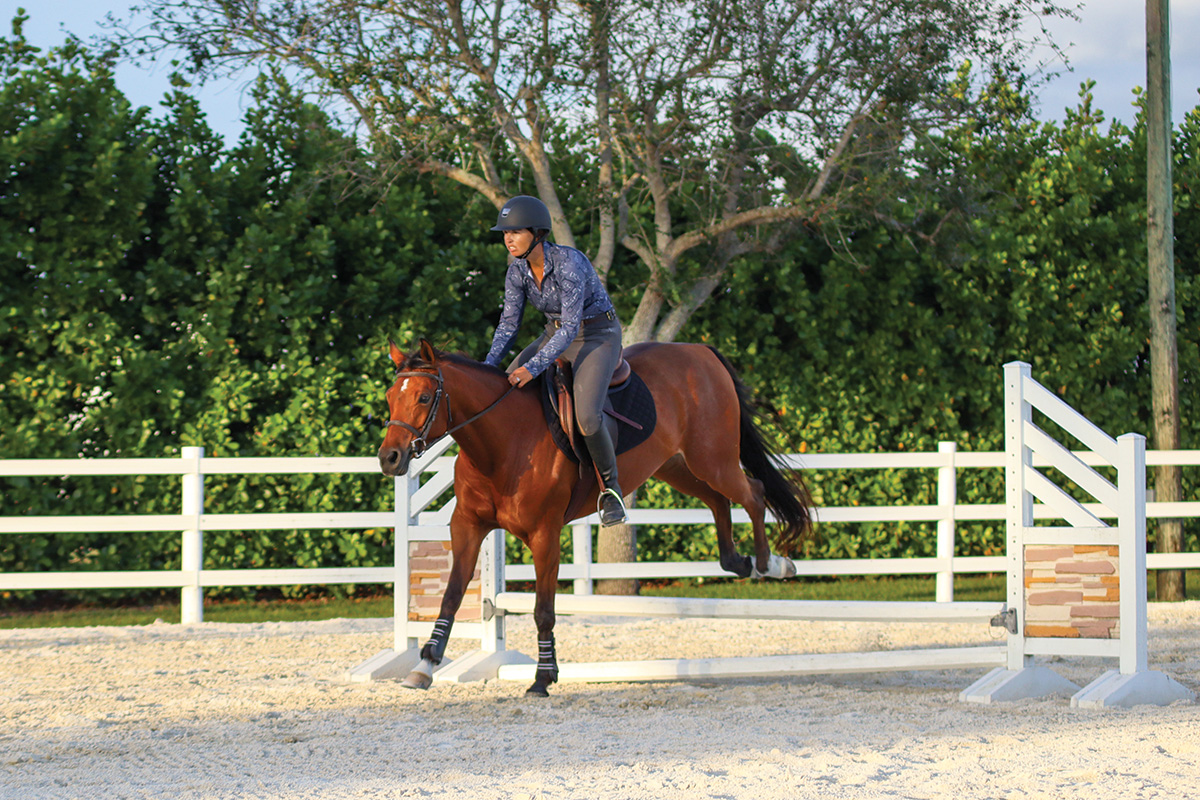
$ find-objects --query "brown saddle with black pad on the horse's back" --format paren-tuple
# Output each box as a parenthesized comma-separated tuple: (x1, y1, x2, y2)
(539, 359, 658, 518)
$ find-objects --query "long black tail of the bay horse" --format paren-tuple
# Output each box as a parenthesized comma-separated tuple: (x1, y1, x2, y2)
(708, 345, 815, 555)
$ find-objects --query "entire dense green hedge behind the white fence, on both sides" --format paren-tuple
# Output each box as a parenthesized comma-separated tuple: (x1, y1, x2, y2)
(0, 38, 1200, 602)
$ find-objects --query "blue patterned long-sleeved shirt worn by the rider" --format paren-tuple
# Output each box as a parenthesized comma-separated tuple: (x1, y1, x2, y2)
(484, 242, 612, 377)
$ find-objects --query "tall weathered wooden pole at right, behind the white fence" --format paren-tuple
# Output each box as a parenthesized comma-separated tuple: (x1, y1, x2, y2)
(1146, 0, 1186, 601)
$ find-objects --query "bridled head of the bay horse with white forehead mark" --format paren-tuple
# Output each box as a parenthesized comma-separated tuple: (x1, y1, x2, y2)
(379, 339, 449, 476)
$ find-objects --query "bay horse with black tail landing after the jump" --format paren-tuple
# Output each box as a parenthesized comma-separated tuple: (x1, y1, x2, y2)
(379, 338, 812, 697)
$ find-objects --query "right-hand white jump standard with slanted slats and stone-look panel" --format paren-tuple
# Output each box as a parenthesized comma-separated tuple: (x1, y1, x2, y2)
(960, 361, 1195, 708)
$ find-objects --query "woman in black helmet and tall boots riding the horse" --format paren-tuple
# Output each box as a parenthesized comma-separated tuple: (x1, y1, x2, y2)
(484, 194, 625, 525)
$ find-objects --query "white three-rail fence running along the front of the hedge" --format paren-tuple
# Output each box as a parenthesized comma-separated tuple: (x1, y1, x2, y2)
(0, 440, 1200, 622)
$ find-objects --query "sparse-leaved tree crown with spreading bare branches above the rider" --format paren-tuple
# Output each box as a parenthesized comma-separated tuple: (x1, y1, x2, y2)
(120, 0, 1069, 342)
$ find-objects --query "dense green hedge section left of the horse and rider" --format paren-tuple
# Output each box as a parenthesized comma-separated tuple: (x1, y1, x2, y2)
(0, 22, 496, 596)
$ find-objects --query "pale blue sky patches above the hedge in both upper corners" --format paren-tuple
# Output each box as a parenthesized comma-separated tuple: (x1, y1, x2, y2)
(7, 0, 1200, 143)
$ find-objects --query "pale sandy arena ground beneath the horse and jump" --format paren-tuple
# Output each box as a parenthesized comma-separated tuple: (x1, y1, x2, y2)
(0, 602, 1200, 800)
